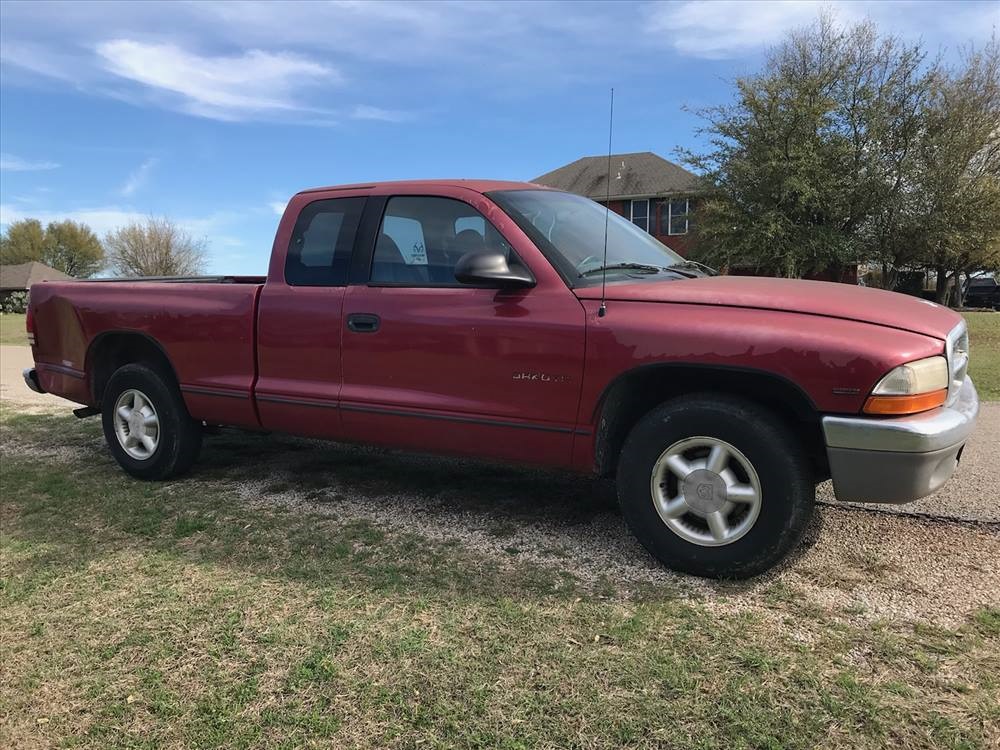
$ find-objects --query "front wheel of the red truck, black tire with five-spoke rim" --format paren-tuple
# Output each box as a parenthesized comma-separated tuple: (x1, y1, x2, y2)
(618, 393, 816, 579)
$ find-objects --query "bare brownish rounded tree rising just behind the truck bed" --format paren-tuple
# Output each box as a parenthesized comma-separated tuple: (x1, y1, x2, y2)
(104, 217, 206, 276)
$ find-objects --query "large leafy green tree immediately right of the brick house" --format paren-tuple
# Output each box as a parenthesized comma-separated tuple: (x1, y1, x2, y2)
(685, 13, 935, 284)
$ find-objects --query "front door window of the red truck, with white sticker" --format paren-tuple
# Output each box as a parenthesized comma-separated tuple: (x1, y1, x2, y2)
(371, 196, 519, 286)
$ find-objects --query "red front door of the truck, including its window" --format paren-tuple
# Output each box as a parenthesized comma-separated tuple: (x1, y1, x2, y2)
(340, 195, 585, 465)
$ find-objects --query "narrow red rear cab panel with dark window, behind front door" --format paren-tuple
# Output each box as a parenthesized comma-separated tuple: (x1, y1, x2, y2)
(255, 197, 366, 437)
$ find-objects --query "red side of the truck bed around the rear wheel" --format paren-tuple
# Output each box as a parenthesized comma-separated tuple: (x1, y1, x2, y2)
(31, 276, 264, 426)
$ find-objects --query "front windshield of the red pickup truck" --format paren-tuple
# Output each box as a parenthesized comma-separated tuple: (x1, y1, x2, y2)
(490, 190, 684, 286)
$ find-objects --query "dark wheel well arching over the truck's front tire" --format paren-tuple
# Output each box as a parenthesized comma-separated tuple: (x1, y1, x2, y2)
(594, 364, 829, 480)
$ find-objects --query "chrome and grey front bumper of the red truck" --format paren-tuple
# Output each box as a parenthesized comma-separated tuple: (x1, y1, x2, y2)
(823, 377, 979, 503)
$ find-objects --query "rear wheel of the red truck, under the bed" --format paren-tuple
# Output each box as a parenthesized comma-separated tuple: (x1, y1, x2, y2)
(101, 364, 202, 480)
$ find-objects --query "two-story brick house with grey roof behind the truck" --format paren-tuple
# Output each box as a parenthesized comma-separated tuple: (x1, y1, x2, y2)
(532, 151, 700, 256)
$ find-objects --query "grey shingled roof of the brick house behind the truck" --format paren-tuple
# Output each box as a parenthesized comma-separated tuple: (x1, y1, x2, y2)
(532, 151, 699, 200)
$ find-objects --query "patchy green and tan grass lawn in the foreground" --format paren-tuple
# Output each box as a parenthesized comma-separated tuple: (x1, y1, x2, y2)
(0, 407, 1000, 749)
